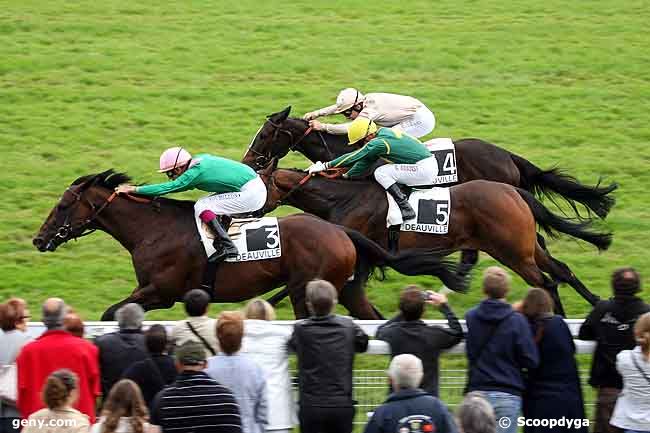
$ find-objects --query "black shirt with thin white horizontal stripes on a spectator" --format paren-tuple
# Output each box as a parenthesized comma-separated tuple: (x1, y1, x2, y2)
(151, 371, 242, 433)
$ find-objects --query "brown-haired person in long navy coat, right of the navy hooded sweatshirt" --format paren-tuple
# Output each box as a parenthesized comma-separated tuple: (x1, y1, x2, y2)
(521, 288, 589, 433)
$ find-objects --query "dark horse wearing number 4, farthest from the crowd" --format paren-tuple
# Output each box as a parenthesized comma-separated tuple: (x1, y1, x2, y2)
(242, 107, 617, 218)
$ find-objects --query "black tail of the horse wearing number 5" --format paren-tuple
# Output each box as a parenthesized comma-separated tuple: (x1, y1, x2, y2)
(517, 188, 612, 251)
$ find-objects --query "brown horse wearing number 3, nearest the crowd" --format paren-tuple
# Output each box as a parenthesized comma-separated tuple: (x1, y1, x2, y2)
(33, 170, 457, 320)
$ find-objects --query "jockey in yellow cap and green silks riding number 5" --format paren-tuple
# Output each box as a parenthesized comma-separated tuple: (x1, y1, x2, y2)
(309, 117, 438, 221)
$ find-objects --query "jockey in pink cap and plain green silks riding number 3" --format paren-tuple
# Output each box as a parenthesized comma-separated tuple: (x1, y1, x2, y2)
(115, 147, 266, 262)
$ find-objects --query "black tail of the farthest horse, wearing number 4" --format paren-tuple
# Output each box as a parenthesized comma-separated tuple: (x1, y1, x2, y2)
(510, 153, 618, 218)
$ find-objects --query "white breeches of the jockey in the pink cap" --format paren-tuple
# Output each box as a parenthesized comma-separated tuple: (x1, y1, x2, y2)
(194, 176, 266, 217)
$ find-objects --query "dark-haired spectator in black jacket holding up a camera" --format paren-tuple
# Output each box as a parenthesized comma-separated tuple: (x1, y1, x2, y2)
(376, 286, 463, 397)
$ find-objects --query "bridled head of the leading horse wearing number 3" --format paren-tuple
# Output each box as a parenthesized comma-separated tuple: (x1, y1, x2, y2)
(32, 170, 130, 252)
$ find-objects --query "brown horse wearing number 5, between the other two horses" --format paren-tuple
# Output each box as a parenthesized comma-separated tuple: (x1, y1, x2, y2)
(260, 165, 611, 314)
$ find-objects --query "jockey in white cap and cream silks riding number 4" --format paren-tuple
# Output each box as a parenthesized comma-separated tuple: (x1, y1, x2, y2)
(303, 88, 436, 138)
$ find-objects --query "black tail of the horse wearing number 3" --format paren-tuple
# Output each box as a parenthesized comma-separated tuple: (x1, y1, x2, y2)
(341, 226, 467, 292)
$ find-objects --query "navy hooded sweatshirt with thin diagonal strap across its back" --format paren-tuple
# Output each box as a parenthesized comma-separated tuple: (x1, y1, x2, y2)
(465, 299, 539, 395)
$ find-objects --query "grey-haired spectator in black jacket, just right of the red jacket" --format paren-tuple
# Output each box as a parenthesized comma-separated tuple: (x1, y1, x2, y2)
(95, 303, 149, 398)
